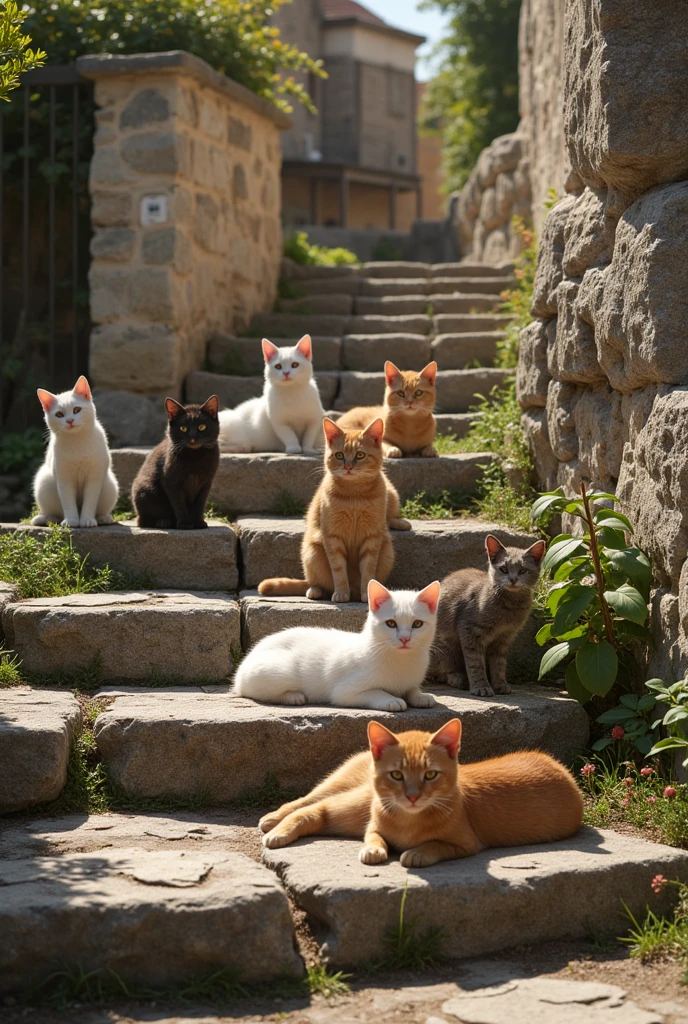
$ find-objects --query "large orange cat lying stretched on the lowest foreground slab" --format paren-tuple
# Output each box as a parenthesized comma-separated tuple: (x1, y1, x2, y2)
(259, 718, 583, 867)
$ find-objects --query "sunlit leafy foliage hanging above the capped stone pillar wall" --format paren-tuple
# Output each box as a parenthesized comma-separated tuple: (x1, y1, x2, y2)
(20, 0, 325, 111)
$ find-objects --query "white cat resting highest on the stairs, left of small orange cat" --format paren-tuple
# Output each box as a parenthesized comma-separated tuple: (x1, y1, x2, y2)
(219, 334, 325, 455)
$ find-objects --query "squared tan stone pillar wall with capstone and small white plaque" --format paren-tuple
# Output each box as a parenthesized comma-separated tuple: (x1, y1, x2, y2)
(78, 51, 290, 403)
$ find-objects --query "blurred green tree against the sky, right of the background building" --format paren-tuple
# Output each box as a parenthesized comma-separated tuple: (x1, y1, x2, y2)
(421, 0, 521, 191)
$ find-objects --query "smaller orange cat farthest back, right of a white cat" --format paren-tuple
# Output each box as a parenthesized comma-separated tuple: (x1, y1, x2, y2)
(337, 359, 437, 459)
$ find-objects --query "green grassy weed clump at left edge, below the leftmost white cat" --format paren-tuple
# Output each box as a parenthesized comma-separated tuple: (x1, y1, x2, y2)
(0, 526, 151, 599)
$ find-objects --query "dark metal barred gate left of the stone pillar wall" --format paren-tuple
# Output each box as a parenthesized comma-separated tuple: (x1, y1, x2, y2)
(0, 67, 93, 431)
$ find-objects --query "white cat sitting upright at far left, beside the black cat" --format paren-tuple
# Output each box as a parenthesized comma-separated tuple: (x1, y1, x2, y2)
(32, 377, 119, 526)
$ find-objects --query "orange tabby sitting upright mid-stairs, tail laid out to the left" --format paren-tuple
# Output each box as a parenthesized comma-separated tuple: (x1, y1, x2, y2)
(258, 417, 411, 603)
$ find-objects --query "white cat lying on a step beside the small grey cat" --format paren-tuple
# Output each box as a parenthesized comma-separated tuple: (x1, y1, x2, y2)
(234, 580, 440, 711)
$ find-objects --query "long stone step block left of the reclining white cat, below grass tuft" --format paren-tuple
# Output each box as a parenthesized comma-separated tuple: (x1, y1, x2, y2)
(2, 590, 241, 682)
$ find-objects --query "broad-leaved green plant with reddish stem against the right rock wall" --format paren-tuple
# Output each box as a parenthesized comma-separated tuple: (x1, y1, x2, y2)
(532, 483, 652, 708)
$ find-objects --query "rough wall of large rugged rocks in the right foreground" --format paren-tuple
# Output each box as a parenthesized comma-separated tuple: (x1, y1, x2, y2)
(517, 0, 688, 678)
